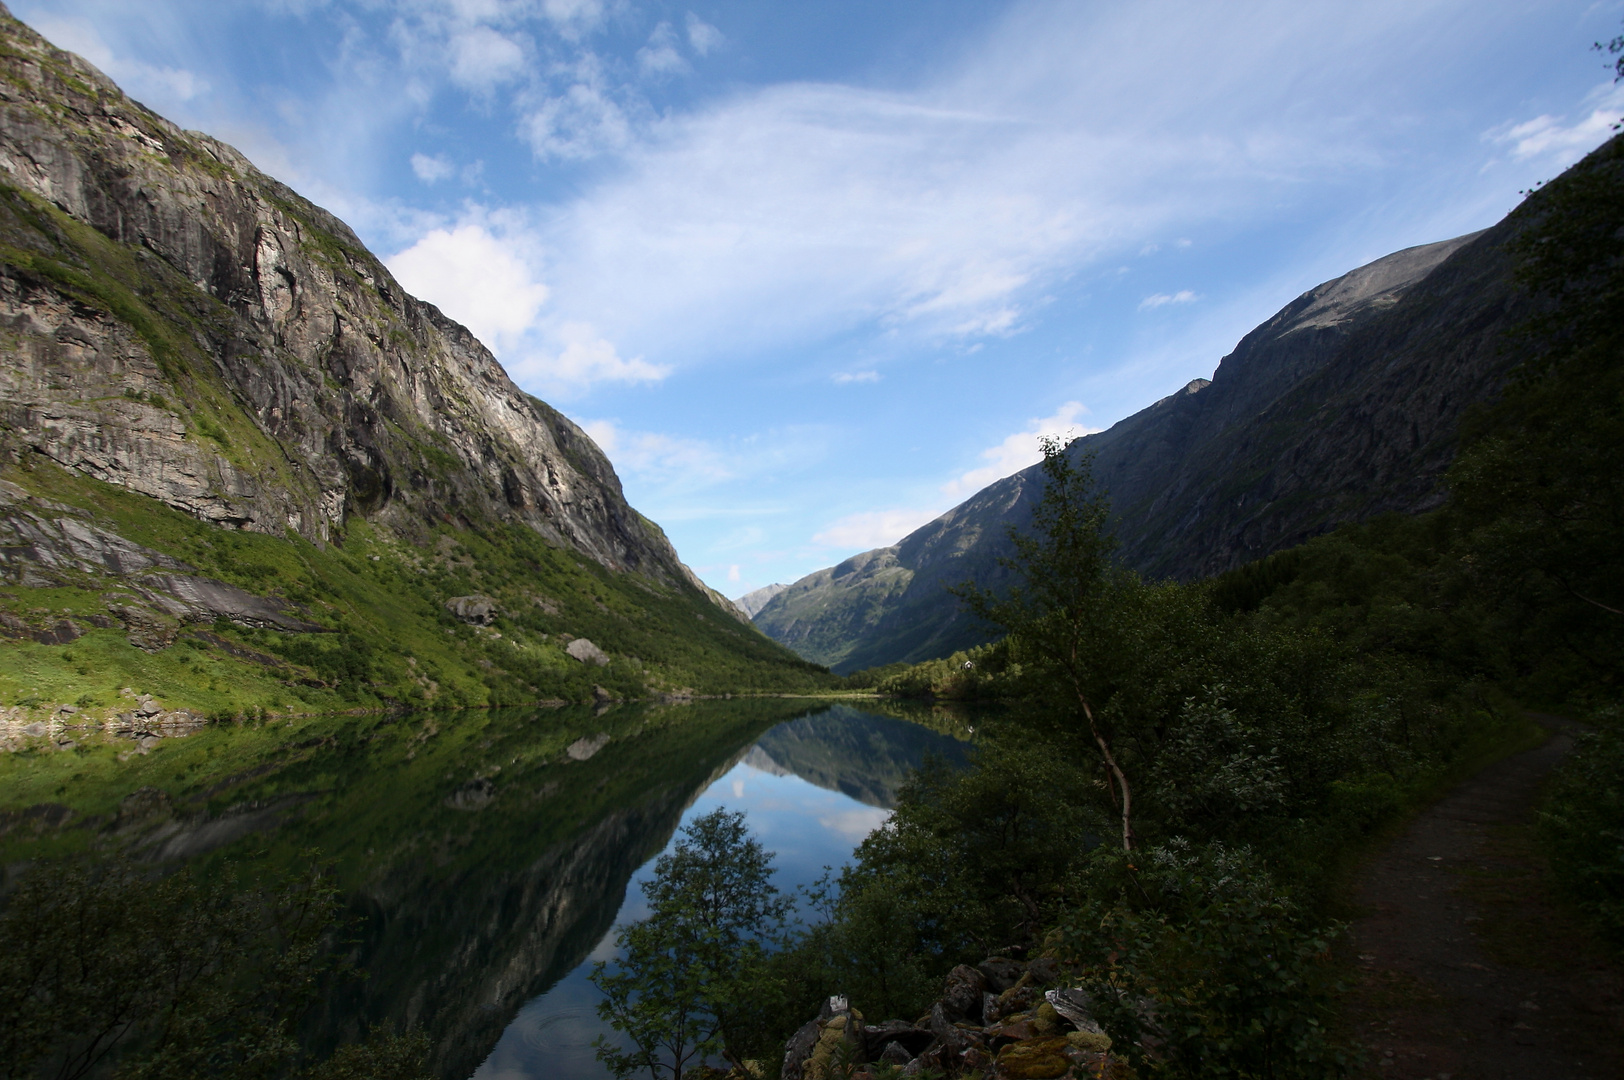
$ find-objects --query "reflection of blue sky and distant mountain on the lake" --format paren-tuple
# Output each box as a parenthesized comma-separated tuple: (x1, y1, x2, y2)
(474, 706, 966, 1080)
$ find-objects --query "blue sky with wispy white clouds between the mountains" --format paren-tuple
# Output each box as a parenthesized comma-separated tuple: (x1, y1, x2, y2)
(11, 0, 1624, 596)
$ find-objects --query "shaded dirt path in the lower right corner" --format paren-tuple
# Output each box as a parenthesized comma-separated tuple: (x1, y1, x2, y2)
(1351, 714, 1624, 1080)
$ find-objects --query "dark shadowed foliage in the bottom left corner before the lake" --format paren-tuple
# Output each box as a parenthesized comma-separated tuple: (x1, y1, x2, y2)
(0, 861, 427, 1080)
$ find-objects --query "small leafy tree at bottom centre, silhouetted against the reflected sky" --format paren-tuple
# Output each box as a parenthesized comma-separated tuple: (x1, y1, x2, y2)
(591, 807, 791, 1080)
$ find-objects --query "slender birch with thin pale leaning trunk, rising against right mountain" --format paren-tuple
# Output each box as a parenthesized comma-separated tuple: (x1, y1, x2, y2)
(955, 437, 1143, 851)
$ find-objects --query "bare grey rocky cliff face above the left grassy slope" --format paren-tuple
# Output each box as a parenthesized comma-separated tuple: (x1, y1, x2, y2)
(0, 6, 717, 597)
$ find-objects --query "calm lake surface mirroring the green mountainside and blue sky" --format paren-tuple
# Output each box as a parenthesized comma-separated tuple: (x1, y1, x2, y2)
(0, 698, 966, 1080)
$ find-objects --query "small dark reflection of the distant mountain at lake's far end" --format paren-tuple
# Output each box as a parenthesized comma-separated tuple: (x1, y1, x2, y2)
(744, 705, 968, 810)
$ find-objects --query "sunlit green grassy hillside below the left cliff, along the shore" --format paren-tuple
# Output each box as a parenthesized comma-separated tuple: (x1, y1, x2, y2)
(0, 456, 830, 719)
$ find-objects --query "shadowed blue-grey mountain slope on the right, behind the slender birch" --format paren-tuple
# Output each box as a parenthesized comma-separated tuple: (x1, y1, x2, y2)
(755, 214, 1527, 672)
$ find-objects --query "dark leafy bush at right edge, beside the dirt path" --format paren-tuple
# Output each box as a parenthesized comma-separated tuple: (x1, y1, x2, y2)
(1540, 715, 1624, 945)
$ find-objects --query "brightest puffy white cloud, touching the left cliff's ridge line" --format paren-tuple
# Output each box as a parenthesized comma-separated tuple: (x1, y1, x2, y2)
(383, 220, 549, 352)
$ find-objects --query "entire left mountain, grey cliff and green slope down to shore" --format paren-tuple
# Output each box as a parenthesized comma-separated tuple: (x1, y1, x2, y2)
(0, 6, 824, 714)
